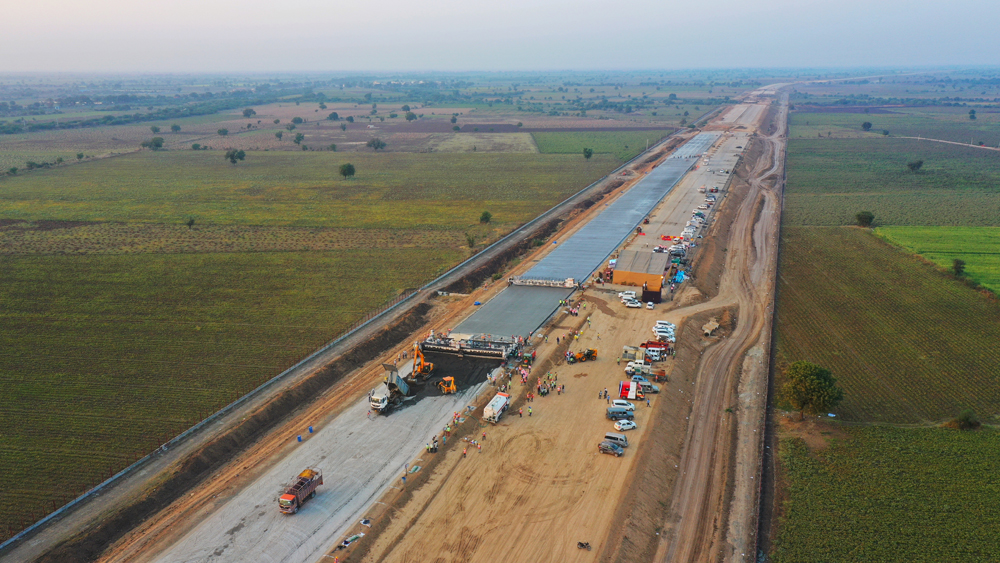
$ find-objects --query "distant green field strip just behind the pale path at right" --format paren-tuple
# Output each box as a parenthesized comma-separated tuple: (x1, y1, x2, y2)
(789, 107, 1000, 147)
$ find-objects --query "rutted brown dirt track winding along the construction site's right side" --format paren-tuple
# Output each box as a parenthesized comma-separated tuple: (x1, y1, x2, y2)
(656, 90, 788, 563)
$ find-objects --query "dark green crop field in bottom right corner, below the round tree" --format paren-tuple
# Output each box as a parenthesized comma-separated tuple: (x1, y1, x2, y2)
(773, 426, 1000, 563)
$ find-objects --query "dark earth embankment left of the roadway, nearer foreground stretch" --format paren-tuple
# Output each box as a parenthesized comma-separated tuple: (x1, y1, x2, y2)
(38, 303, 431, 563)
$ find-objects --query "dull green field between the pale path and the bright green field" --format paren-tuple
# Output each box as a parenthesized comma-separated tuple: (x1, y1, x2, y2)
(782, 139, 1000, 226)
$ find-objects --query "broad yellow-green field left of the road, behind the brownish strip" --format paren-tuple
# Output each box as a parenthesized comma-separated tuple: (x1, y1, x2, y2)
(0, 151, 618, 230)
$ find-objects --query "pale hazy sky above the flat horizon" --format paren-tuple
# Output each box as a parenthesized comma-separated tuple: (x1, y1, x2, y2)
(0, 0, 1000, 72)
